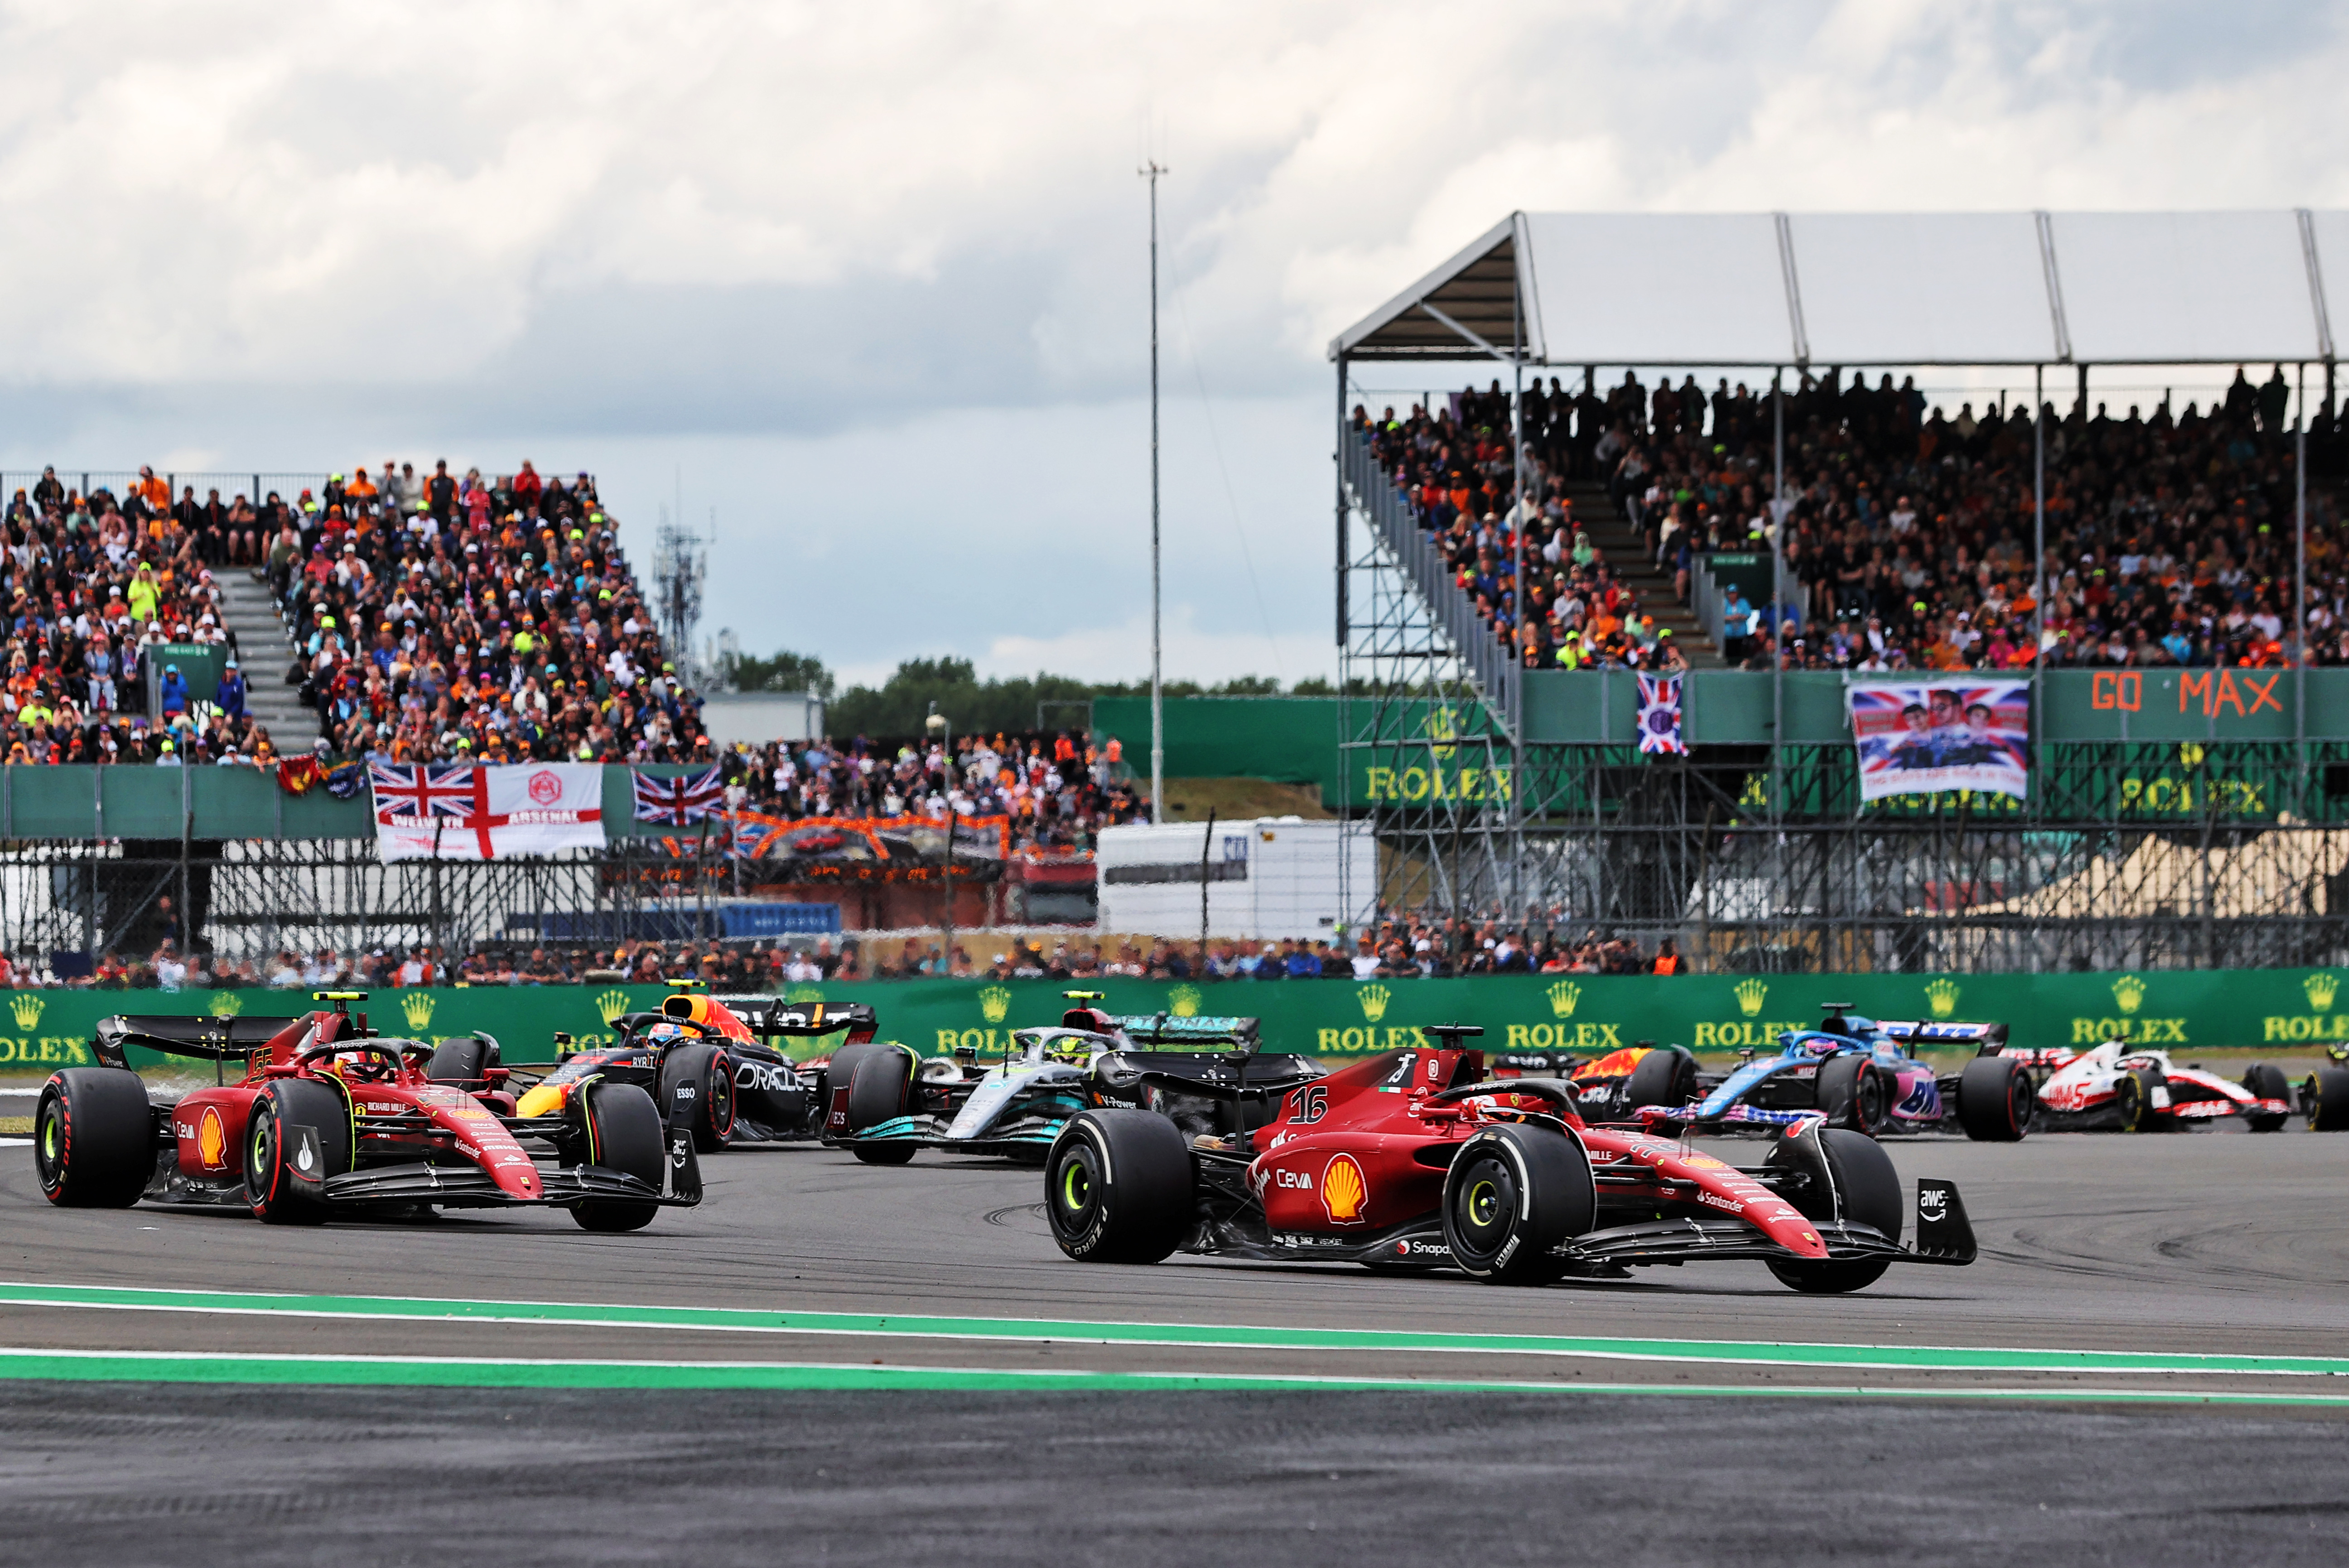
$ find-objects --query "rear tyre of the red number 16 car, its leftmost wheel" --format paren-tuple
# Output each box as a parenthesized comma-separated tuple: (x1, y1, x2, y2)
(1043, 1108, 1198, 1263)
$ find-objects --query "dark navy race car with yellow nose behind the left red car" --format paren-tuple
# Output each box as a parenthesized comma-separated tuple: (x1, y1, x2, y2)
(519, 988, 878, 1155)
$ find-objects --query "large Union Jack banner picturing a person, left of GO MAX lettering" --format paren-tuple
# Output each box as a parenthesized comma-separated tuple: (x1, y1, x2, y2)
(1849, 681, 2032, 801)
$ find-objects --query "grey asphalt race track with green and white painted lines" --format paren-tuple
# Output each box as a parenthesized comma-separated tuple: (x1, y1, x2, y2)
(0, 1129, 2349, 1566)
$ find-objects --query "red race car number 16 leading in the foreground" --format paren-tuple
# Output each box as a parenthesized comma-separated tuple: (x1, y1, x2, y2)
(1045, 1023, 1976, 1293)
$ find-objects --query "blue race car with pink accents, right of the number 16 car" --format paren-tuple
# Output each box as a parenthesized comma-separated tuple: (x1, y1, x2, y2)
(1621, 1002, 2032, 1143)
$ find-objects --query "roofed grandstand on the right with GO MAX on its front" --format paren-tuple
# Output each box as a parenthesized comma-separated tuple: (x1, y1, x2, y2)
(1332, 211, 2349, 970)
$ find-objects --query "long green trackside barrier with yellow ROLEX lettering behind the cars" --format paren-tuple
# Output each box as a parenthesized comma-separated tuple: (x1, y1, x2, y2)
(18, 970, 2349, 1073)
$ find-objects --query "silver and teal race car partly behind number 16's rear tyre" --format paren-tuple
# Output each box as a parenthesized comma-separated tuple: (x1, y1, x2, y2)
(825, 990, 1320, 1164)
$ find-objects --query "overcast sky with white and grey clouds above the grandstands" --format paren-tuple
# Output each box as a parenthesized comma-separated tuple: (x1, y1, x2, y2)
(0, 0, 2349, 681)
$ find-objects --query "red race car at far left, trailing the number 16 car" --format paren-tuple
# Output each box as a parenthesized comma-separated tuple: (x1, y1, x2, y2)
(33, 990, 702, 1230)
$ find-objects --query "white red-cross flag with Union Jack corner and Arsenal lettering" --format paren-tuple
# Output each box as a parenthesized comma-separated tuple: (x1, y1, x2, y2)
(367, 763, 604, 861)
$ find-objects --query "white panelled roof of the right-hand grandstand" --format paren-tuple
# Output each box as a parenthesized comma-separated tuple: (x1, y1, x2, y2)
(1330, 209, 2349, 366)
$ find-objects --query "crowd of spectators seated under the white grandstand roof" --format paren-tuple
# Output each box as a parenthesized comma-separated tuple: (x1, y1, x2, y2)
(1355, 366, 2349, 671)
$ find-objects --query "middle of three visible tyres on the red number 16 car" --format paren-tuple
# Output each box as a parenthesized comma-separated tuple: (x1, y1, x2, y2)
(1445, 1122, 1597, 1284)
